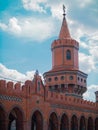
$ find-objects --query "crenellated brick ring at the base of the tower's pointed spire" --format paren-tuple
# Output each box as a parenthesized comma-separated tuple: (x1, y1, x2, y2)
(51, 39, 79, 49)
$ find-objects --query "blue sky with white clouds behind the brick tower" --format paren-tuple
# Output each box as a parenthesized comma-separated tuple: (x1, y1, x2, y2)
(0, 0, 98, 101)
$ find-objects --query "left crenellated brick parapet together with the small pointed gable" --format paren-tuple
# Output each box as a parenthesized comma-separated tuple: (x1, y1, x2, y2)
(0, 77, 44, 97)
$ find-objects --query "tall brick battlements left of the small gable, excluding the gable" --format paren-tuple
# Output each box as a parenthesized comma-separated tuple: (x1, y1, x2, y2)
(0, 80, 43, 97)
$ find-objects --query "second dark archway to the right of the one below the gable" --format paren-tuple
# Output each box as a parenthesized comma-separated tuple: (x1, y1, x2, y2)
(60, 113, 69, 130)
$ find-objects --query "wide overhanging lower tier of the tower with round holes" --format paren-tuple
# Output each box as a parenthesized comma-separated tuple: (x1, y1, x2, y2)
(44, 70, 87, 97)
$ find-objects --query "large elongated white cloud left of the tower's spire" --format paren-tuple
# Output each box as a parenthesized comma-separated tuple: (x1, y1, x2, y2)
(0, 17, 56, 42)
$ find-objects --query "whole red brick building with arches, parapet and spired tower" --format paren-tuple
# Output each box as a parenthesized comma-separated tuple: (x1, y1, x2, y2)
(0, 9, 98, 130)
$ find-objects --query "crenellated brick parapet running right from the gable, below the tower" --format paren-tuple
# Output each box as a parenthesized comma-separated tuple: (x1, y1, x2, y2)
(46, 91, 98, 110)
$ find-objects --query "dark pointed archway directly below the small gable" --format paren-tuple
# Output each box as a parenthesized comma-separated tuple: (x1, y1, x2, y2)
(31, 110, 43, 130)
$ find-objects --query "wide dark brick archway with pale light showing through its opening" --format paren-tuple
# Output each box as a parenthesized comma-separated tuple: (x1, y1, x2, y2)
(8, 105, 25, 130)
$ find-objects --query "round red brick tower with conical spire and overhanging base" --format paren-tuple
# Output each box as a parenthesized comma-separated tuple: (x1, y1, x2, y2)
(44, 7, 87, 98)
